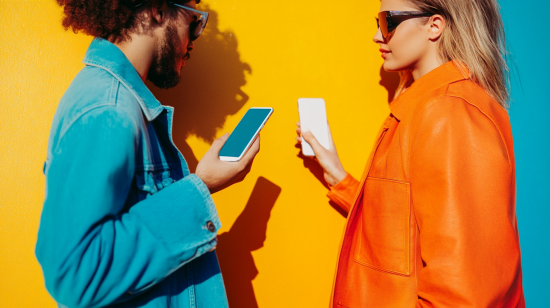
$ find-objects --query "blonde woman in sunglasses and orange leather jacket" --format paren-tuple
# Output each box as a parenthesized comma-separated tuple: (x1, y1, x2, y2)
(297, 0, 525, 307)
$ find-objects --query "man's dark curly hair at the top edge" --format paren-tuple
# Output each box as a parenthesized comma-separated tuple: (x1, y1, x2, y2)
(57, 0, 200, 42)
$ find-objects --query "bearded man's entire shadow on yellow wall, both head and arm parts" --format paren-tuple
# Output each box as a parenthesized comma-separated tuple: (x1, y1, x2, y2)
(147, 6, 281, 308)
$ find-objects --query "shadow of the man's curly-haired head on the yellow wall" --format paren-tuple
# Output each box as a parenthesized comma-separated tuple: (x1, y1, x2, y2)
(147, 5, 252, 173)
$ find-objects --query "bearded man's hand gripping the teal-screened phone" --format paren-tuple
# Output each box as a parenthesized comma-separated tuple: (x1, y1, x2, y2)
(195, 134, 260, 194)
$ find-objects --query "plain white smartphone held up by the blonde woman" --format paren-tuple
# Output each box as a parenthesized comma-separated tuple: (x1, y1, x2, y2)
(298, 98, 330, 156)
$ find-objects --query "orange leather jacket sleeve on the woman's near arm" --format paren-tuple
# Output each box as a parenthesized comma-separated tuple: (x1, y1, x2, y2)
(410, 97, 521, 307)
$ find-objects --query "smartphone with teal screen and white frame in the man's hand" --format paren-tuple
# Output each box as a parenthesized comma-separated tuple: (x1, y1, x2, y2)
(219, 107, 273, 161)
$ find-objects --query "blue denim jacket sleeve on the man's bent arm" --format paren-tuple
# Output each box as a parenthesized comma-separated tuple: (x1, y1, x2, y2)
(36, 106, 221, 307)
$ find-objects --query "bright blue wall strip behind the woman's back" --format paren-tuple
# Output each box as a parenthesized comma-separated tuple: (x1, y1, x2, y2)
(500, 0, 550, 308)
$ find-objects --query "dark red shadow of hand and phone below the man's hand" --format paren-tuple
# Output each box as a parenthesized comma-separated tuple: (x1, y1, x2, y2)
(216, 177, 281, 308)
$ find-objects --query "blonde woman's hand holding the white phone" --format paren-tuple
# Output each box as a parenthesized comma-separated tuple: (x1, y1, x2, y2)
(296, 122, 347, 186)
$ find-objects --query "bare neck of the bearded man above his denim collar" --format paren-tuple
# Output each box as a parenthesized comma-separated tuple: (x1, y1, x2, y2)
(114, 35, 156, 81)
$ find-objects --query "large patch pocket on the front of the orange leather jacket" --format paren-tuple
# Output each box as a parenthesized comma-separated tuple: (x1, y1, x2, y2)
(354, 177, 411, 276)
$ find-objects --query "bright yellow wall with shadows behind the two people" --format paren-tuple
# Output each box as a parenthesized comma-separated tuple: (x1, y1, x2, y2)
(0, 0, 395, 308)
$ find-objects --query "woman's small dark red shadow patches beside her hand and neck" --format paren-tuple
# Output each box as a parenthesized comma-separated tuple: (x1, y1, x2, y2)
(296, 66, 400, 217)
